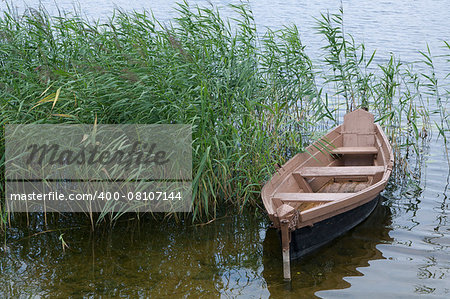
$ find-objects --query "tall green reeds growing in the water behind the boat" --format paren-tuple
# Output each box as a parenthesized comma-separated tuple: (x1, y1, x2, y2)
(0, 3, 450, 226)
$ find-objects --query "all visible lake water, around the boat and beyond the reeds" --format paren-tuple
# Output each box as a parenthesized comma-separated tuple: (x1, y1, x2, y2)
(0, 0, 450, 298)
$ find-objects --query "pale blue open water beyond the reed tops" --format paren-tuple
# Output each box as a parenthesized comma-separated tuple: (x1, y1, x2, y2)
(5, 0, 450, 64)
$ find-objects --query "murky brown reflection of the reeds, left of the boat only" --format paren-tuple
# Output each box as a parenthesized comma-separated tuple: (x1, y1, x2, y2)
(0, 216, 268, 298)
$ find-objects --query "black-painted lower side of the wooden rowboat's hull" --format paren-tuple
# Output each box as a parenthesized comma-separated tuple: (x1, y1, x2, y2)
(280, 195, 379, 259)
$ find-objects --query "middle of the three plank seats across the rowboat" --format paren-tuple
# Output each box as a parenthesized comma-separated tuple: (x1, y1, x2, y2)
(294, 166, 384, 177)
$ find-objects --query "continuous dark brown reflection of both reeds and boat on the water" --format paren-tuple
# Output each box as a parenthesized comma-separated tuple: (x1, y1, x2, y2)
(0, 204, 392, 298)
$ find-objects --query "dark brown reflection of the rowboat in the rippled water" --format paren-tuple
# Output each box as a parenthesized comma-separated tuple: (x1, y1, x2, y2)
(262, 203, 392, 298)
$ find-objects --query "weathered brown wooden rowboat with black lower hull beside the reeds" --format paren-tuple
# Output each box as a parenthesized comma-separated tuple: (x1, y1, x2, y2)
(261, 109, 394, 280)
